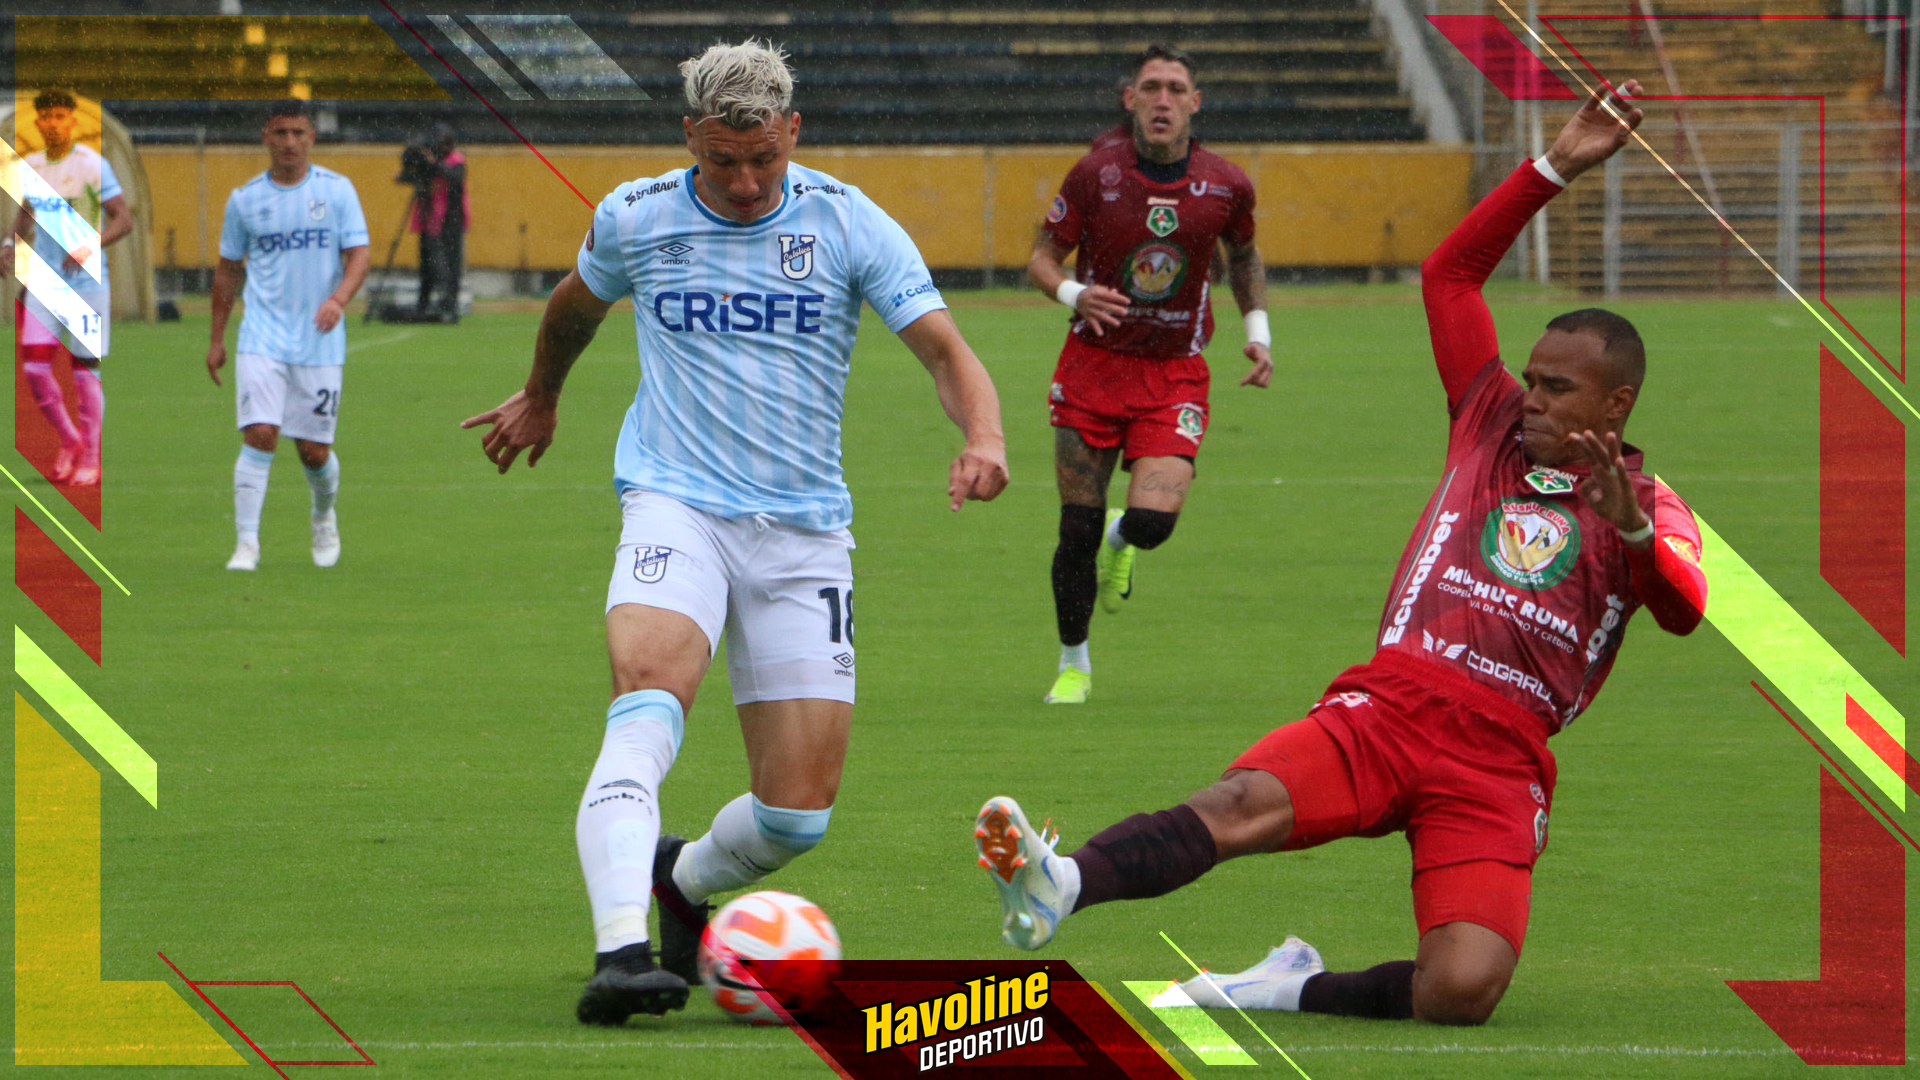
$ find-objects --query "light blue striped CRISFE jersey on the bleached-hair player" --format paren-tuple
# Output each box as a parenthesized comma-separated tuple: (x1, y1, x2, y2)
(576, 165, 947, 530)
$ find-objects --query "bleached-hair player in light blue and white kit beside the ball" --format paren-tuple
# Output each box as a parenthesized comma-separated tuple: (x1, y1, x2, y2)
(463, 40, 1006, 1024)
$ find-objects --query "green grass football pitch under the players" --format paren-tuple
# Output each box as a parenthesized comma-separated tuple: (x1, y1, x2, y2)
(0, 286, 1920, 1080)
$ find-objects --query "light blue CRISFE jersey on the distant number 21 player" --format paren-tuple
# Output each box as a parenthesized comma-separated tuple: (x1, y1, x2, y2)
(221, 165, 367, 367)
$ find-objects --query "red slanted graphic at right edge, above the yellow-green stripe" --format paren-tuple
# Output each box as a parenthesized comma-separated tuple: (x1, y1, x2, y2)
(1820, 344, 1907, 655)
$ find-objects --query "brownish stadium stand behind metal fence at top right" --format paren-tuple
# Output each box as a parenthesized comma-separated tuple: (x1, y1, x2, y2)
(1451, 0, 1901, 292)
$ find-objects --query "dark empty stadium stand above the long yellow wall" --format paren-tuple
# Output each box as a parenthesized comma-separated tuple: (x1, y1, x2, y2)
(17, 0, 1425, 146)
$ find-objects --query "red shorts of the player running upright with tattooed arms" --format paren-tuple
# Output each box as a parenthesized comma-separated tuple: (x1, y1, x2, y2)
(1048, 334, 1210, 457)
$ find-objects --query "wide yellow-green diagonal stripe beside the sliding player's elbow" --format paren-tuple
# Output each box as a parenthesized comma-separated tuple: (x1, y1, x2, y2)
(1693, 513, 1907, 809)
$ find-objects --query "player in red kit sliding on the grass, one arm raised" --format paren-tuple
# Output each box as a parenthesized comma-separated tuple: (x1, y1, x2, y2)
(973, 83, 1707, 1024)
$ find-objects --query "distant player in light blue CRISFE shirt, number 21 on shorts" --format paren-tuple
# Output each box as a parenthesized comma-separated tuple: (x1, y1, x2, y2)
(207, 100, 372, 571)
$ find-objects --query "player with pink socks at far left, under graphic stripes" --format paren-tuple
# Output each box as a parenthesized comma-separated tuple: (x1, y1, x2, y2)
(0, 88, 132, 486)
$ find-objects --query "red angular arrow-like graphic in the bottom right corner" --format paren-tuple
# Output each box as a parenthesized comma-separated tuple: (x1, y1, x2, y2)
(1726, 769, 1907, 1065)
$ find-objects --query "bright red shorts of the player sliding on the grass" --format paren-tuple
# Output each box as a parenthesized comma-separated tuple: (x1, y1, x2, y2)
(1233, 645, 1555, 953)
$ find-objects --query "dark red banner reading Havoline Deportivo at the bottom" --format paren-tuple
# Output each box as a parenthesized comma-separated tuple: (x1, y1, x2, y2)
(795, 961, 1181, 1080)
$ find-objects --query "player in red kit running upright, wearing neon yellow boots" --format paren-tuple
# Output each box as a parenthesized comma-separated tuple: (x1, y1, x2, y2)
(1027, 44, 1273, 705)
